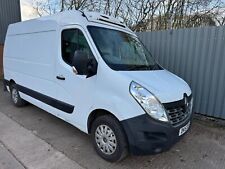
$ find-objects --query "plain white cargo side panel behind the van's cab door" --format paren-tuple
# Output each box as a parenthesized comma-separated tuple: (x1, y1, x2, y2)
(4, 31, 57, 101)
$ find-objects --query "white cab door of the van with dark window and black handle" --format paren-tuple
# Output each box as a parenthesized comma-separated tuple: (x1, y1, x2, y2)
(55, 26, 96, 126)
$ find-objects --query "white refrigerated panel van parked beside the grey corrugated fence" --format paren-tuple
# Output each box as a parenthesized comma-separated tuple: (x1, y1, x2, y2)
(4, 11, 193, 161)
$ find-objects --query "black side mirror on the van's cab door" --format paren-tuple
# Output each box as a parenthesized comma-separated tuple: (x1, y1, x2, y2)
(72, 51, 98, 78)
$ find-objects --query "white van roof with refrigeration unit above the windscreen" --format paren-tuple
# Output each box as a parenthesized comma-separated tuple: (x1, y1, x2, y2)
(7, 10, 131, 35)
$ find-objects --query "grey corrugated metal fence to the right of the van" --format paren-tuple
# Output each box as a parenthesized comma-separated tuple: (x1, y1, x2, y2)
(137, 27, 225, 119)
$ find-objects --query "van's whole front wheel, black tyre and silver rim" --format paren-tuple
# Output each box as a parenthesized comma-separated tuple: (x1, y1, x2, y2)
(91, 115, 128, 162)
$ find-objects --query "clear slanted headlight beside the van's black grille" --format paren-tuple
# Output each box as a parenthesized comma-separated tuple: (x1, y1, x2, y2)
(130, 82, 168, 122)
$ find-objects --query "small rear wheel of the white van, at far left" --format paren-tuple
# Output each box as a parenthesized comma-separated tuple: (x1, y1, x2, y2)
(10, 84, 26, 107)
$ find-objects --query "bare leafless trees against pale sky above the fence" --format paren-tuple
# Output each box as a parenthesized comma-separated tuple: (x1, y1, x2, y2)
(33, 0, 225, 31)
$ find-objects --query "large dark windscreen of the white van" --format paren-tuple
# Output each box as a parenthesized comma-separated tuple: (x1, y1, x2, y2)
(88, 26, 162, 71)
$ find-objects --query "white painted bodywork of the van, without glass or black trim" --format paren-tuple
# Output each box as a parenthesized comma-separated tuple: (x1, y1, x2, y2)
(4, 11, 191, 132)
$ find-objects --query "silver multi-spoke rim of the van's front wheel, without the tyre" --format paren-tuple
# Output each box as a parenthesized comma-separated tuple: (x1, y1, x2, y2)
(95, 125, 117, 155)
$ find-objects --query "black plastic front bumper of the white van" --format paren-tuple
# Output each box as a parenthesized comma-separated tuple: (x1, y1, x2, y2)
(122, 114, 192, 155)
